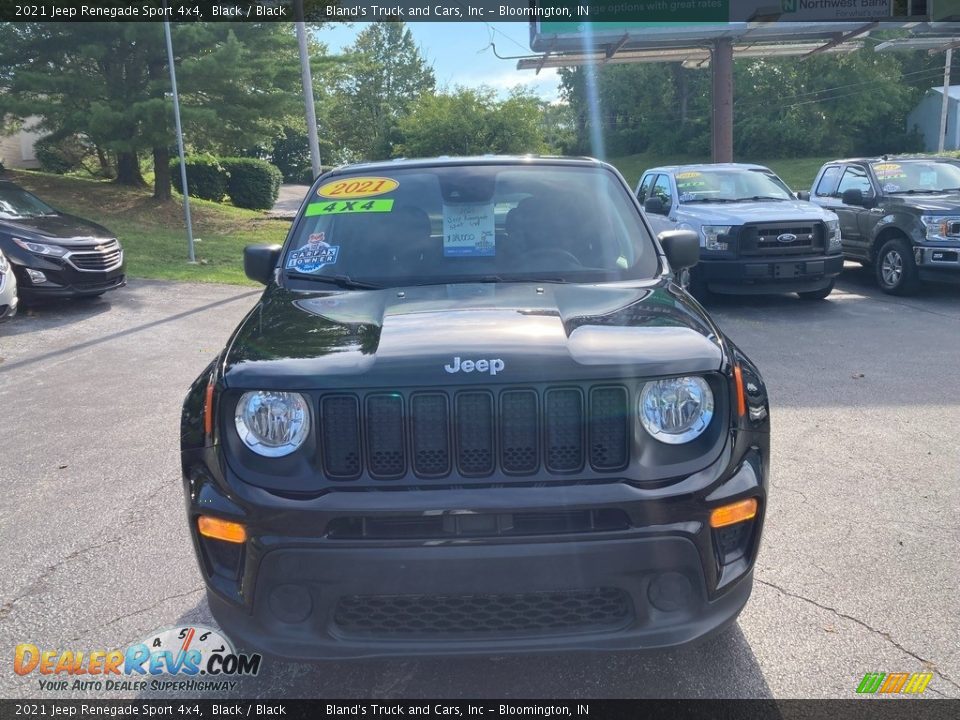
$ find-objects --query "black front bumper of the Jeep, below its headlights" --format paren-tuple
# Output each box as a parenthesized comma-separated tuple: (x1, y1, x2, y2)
(184, 434, 769, 659)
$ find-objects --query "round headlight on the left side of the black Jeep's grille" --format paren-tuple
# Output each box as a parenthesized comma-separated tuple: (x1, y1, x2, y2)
(235, 390, 310, 457)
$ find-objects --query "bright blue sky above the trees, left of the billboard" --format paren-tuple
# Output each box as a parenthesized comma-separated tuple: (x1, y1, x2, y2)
(316, 22, 559, 102)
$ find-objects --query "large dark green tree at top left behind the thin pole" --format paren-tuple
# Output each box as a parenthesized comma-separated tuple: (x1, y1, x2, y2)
(0, 23, 298, 199)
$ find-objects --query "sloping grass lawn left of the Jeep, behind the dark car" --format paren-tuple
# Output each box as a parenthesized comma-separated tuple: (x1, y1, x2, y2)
(3, 171, 290, 285)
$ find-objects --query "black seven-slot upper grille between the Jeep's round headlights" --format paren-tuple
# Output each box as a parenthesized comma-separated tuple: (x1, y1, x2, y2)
(319, 385, 630, 480)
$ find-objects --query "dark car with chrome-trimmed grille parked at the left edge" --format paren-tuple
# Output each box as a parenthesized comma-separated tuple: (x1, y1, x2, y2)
(0, 180, 126, 300)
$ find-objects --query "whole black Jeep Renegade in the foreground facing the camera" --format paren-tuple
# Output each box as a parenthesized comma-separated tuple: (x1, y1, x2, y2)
(181, 157, 770, 658)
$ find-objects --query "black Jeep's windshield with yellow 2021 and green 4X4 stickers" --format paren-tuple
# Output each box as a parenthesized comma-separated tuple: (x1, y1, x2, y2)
(281, 163, 659, 289)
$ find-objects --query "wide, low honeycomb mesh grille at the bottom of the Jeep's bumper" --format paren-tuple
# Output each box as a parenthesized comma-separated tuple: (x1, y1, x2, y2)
(334, 588, 633, 637)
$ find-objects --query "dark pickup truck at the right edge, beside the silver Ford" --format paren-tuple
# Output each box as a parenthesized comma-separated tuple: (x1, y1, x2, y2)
(810, 156, 960, 295)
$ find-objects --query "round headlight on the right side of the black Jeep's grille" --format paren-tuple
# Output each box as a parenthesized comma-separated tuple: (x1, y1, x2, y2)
(639, 376, 713, 445)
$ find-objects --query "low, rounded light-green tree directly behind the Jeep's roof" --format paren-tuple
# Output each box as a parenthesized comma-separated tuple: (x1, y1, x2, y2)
(395, 87, 546, 157)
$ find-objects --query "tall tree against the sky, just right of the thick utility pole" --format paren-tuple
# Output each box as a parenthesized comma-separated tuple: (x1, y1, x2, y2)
(331, 22, 435, 160)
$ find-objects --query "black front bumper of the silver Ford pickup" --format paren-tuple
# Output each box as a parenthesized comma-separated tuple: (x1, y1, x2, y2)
(691, 254, 843, 294)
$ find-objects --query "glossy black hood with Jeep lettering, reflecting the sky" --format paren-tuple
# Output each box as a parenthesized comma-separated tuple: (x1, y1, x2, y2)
(222, 282, 723, 390)
